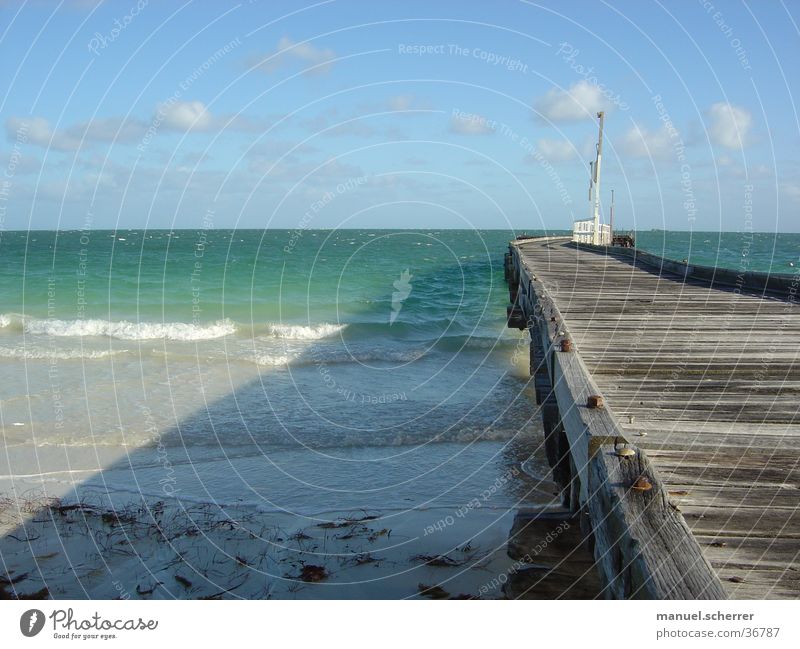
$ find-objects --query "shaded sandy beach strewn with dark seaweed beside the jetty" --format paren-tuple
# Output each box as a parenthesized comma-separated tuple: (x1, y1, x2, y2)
(0, 486, 544, 599)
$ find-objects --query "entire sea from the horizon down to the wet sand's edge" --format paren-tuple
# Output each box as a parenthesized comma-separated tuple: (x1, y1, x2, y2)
(0, 230, 800, 511)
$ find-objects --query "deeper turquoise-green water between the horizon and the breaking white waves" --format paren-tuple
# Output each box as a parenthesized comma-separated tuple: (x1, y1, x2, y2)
(0, 230, 800, 326)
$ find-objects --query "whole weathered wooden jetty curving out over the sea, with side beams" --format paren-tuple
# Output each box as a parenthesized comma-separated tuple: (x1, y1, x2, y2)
(505, 237, 800, 599)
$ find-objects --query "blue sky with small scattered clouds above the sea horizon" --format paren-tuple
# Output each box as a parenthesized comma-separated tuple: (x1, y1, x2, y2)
(0, 0, 800, 232)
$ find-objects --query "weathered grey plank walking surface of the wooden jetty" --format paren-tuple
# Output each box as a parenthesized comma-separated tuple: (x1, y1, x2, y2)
(509, 238, 800, 599)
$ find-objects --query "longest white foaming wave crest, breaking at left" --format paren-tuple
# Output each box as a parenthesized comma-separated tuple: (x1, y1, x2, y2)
(24, 319, 236, 341)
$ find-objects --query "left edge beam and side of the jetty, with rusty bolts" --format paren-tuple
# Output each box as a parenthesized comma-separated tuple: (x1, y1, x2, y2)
(505, 237, 726, 599)
